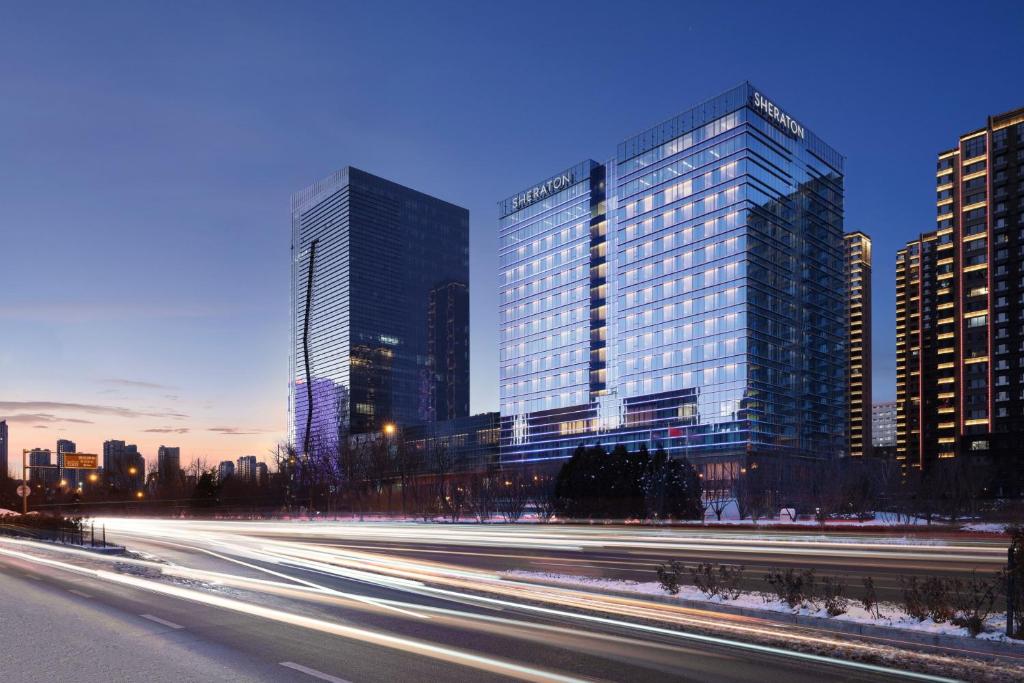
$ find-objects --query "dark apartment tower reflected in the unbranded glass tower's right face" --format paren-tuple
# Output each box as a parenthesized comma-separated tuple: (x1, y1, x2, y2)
(427, 283, 469, 422)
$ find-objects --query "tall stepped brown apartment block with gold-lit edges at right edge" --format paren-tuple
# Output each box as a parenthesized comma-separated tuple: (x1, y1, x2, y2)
(896, 109, 1024, 487)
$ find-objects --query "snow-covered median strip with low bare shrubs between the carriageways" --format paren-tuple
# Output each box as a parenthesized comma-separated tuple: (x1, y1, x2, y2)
(502, 569, 1024, 646)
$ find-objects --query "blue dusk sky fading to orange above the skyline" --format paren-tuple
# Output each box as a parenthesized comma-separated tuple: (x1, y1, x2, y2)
(0, 0, 1024, 475)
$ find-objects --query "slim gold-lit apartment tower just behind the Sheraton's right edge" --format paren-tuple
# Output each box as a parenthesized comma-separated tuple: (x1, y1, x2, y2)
(845, 230, 871, 458)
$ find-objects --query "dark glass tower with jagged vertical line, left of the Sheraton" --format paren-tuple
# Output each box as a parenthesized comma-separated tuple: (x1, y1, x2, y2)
(289, 167, 469, 453)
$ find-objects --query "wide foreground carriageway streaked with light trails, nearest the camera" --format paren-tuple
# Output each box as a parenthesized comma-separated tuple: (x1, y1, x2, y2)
(0, 519, 1007, 683)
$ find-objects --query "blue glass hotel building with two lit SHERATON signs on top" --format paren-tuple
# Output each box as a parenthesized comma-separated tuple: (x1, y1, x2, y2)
(499, 83, 848, 471)
